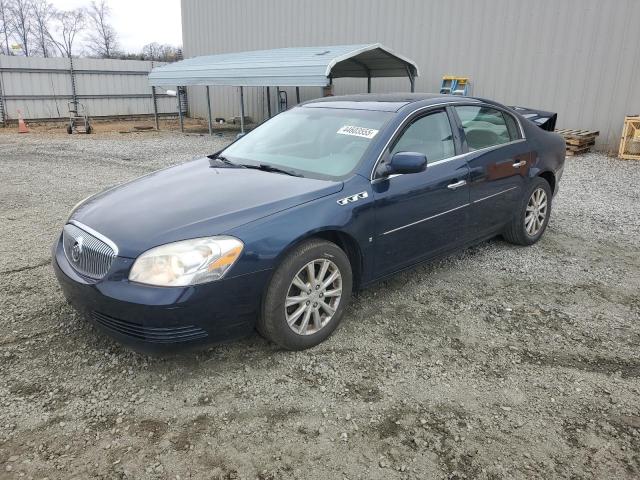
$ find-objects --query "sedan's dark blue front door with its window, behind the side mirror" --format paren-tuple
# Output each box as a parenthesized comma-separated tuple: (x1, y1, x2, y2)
(372, 110, 469, 275)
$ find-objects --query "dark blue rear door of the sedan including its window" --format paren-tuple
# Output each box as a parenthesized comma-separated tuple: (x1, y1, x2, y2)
(453, 104, 534, 237)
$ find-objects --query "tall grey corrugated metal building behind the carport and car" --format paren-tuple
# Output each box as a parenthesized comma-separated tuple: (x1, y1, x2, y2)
(182, 0, 640, 150)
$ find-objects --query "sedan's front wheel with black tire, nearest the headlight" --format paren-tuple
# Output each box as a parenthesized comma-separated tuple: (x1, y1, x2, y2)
(257, 240, 353, 350)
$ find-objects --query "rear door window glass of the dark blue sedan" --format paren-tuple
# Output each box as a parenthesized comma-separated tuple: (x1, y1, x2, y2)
(455, 105, 521, 150)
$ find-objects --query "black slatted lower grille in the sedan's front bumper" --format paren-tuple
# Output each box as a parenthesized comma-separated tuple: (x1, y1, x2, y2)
(91, 312, 207, 343)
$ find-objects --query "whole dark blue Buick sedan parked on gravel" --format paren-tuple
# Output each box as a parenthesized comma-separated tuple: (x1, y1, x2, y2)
(53, 94, 565, 351)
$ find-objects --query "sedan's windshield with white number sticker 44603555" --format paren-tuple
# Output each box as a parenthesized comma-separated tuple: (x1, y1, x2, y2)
(220, 107, 393, 178)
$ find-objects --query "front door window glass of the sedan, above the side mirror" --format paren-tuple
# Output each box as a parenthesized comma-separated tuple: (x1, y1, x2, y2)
(391, 111, 455, 162)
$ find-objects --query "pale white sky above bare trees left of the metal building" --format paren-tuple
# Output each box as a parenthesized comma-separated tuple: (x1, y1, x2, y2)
(49, 0, 182, 53)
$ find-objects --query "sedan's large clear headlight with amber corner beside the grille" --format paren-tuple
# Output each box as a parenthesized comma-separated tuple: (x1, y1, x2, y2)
(129, 236, 244, 287)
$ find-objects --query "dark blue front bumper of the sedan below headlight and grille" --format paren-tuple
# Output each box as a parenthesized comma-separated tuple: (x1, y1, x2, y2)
(52, 234, 271, 353)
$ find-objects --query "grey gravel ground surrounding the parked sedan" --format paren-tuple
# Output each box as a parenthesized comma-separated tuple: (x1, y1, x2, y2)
(0, 133, 640, 480)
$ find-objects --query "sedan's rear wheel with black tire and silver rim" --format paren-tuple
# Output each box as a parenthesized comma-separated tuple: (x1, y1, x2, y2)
(502, 177, 552, 245)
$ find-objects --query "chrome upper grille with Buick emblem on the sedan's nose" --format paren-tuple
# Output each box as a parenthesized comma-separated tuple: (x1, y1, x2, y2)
(62, 223, 116, 280)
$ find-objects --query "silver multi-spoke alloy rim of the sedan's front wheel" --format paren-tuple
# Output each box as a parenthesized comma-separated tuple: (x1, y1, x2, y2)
(285, 258, 342, 335)
